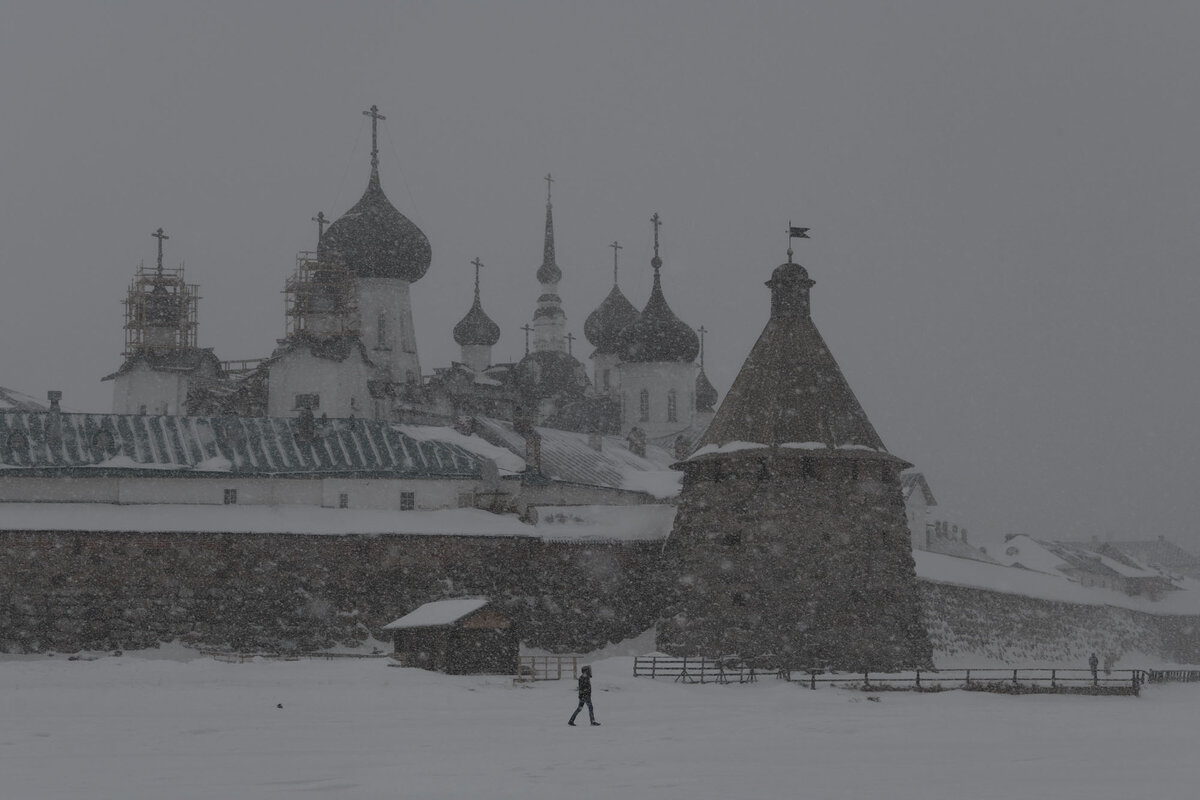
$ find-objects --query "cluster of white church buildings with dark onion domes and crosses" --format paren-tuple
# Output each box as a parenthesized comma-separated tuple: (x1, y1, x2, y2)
(107, 107, 716, 452)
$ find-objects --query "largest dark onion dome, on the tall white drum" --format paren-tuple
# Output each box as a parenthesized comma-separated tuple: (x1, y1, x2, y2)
(319, 169, 433, 283)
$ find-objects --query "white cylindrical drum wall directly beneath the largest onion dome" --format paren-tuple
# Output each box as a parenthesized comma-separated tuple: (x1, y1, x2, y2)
(359, 278, 421, 383)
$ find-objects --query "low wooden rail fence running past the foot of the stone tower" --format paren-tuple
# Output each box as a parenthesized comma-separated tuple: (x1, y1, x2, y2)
(634, 656, 1142, 694)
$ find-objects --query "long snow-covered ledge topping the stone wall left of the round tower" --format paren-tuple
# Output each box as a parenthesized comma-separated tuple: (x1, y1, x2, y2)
(0, 503, 539, 536)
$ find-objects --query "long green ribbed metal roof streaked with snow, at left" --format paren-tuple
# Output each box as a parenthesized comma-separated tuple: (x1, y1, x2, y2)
(0, 411, 484, 477)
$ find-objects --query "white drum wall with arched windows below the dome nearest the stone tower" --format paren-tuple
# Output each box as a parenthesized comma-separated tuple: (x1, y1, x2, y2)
(619, 362, 697, 439)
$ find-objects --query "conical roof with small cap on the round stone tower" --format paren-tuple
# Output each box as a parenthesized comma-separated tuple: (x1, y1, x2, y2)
(700, 261, 887, 452)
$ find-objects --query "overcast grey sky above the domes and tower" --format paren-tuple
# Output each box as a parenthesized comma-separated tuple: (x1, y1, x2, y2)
(0, 0, 1200, 547)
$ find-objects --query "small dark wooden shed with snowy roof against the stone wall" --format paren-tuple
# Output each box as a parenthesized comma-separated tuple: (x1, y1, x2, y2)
(383, 597, 520, 675)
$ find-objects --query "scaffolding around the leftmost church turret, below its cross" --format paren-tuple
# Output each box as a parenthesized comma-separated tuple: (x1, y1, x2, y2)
(122, 261, 199, 357)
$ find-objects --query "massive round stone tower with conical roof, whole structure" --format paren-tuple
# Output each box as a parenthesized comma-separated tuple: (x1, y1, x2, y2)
(658, 239, 932, 670)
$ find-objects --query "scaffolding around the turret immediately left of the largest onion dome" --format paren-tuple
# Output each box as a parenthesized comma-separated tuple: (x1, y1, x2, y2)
(283, 251, 360, 337)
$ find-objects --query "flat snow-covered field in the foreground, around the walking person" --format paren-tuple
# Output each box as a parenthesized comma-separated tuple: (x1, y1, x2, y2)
(0, 650, 1200, 800)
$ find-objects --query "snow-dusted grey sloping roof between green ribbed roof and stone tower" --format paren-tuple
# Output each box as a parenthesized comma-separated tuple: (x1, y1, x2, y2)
(475, 417, 678, 498)
